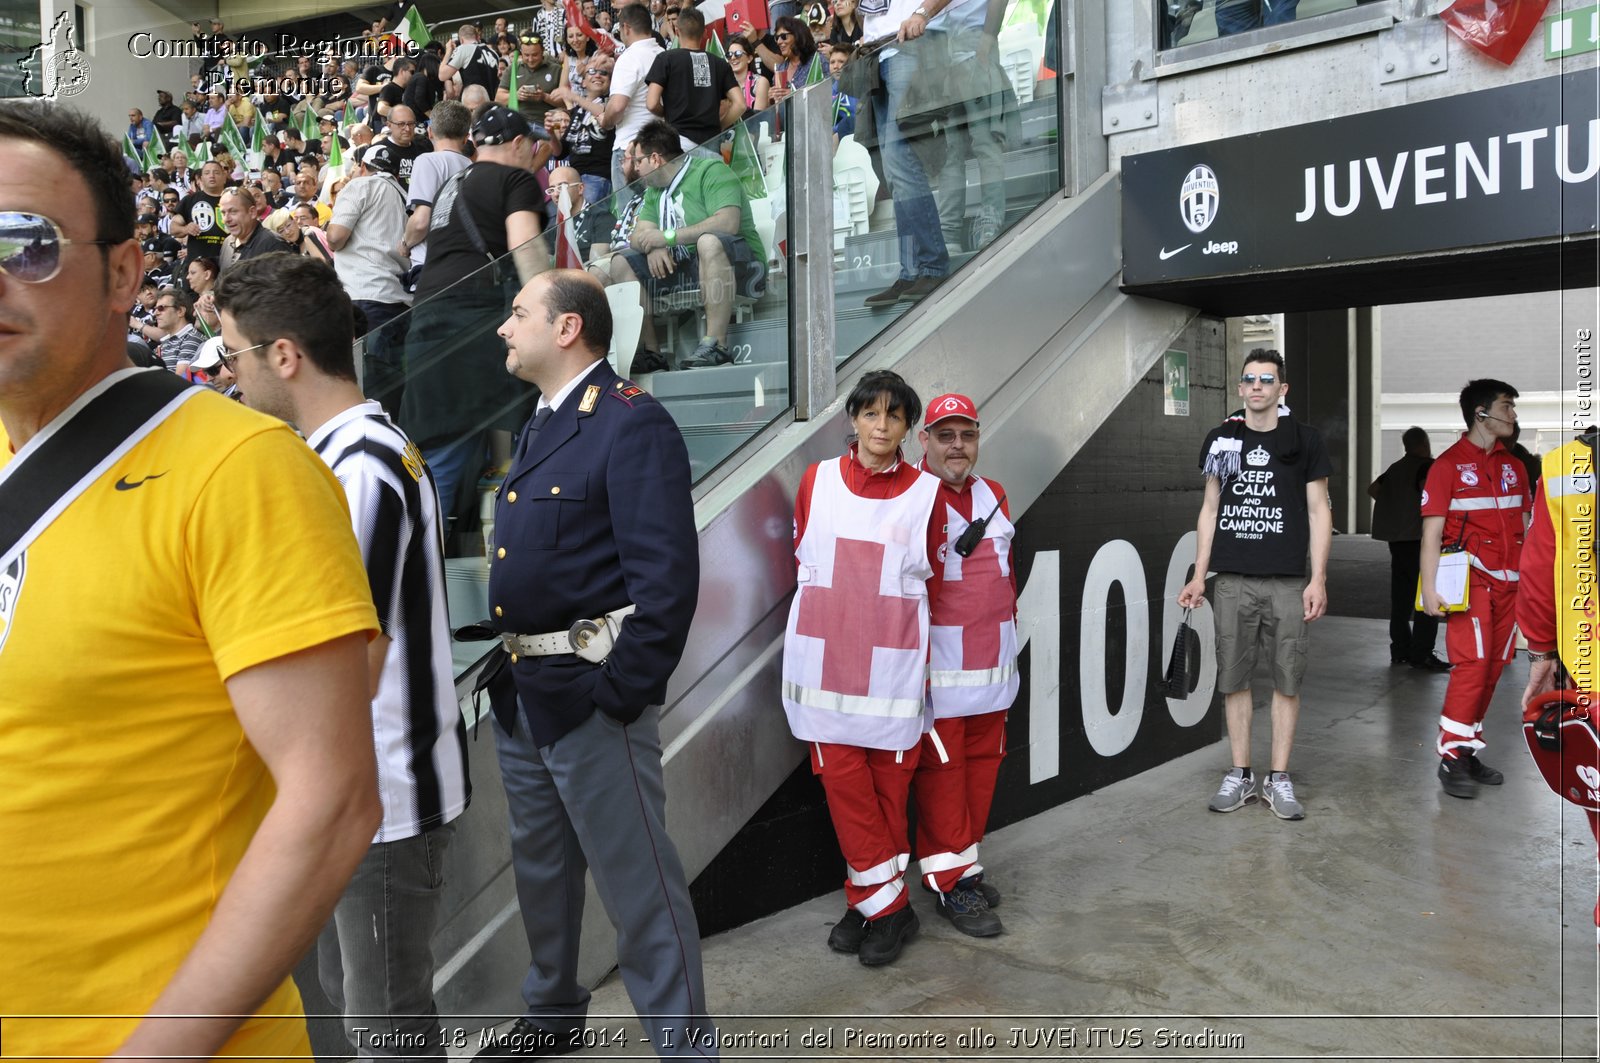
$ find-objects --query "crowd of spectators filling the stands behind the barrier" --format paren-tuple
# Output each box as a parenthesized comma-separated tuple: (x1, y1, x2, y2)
(125, 0, 1014, 528)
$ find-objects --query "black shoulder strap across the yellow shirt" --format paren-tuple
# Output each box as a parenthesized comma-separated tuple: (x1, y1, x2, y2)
(0, 370, 202, 572)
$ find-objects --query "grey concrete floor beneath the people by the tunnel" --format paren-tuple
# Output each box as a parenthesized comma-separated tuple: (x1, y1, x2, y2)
(537, 616, 1597, 1060)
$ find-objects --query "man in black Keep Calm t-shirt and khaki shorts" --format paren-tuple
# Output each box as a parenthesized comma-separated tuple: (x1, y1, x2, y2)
(1178, 347, 1333, 820)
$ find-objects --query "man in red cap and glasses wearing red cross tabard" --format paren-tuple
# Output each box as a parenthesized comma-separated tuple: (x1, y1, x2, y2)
(910, 395, 1021, 938)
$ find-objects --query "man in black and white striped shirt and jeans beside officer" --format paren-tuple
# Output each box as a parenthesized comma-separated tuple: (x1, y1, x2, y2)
(216, 255, 470, 1060)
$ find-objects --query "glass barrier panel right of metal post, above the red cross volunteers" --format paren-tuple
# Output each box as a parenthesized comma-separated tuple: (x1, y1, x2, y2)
(805, 0, 1062, 362)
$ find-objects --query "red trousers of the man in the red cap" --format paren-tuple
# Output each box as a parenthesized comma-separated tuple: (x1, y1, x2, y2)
(910, 709, 1006, 893)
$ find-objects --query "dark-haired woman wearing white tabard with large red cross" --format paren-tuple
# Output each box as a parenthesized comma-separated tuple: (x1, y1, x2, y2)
(782, 370, 939, 967)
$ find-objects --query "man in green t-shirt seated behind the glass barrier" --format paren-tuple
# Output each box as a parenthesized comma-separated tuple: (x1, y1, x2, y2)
(608, 118, 766, 371)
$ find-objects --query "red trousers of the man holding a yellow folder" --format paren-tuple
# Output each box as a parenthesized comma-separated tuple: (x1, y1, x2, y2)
(1438, 568, 1517, 757)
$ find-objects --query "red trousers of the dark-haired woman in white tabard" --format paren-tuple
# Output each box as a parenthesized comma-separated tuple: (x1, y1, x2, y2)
(811, 741, 920, 919)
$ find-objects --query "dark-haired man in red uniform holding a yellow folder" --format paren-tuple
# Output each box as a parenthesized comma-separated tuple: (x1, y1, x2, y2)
(1422, 379, 1533, 797)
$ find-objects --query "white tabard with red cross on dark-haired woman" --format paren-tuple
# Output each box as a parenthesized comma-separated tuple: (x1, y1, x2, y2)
(784, 461, 939, 749)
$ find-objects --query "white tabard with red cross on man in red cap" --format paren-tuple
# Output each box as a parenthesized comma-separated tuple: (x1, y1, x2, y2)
(928, 477, 1021, 719)
